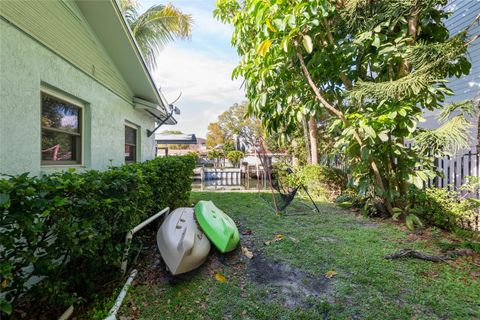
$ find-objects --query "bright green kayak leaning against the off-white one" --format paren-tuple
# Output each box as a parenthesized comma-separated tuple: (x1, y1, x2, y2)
(195, 201, 240, 253)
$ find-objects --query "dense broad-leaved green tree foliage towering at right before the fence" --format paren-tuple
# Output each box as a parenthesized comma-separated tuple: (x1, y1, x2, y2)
(215, 0, 478, 215)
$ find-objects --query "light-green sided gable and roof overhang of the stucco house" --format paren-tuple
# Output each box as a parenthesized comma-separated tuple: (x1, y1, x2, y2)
(0, 0, 176, 124)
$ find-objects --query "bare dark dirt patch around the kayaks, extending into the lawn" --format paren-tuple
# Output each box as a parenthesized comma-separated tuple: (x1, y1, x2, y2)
(131, 222, 338, 308)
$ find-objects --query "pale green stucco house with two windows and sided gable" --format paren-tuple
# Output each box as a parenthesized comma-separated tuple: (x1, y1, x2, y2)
(0, 0, 175, 175)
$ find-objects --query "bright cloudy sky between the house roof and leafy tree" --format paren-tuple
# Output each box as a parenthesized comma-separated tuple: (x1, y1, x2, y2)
(139, 0, 245, 138)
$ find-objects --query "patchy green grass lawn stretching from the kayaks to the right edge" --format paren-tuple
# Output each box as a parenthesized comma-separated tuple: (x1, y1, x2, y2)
(117, 192, 480, 319)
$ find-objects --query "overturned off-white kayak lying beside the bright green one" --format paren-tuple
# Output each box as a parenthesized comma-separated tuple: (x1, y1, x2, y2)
(157, 208, 210, 275)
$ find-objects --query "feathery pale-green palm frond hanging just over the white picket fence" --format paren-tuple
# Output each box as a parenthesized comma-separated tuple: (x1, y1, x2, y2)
(414, 115, 473, 157)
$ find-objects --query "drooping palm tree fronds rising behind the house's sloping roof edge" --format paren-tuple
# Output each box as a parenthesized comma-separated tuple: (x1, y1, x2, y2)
(119, 0, 193, 70)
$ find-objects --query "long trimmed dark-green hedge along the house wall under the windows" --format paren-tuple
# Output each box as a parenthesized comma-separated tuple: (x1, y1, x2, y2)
(0, 157, 195, 313)
